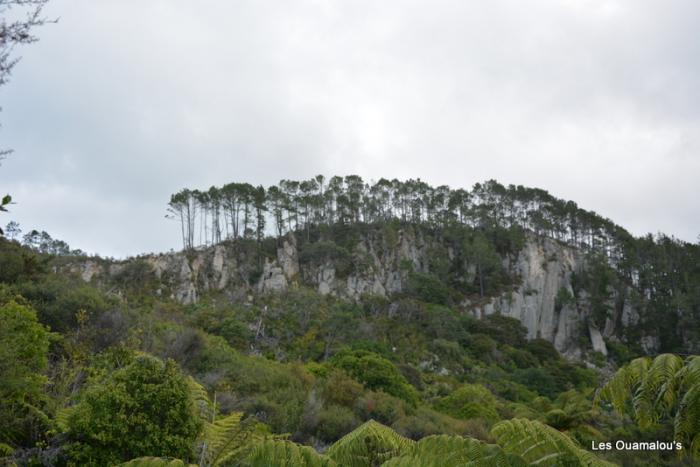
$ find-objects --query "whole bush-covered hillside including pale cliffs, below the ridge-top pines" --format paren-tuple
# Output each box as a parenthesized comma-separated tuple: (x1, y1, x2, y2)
(0, 177, 699, 465)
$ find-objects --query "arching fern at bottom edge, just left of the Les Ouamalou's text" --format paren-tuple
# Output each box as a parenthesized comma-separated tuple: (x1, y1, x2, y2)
(491, 418, 614, 467)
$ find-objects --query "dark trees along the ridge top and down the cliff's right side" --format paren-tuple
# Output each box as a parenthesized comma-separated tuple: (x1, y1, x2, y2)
(168, 175, 700, 352)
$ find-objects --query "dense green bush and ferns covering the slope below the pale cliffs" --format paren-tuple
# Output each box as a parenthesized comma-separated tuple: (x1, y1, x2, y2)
(0, 226, 699, 466)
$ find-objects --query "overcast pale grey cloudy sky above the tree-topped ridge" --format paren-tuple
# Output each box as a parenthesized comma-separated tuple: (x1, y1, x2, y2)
(0, 0, 700, 257)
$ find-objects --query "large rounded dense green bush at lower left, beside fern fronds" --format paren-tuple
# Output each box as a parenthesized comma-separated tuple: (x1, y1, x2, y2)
(68, 356, 202, 465)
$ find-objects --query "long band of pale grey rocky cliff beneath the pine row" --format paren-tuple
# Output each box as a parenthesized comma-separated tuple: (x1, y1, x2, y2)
(72, 226, 659, 360)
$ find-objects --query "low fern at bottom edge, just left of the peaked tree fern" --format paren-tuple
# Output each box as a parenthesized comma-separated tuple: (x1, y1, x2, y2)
(241, 440, 336, 467)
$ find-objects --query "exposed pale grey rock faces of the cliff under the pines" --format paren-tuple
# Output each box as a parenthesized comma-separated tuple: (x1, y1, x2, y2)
(74, 229, 658, 359)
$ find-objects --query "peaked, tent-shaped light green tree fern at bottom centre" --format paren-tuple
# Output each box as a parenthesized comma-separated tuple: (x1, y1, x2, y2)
(328, 420, 414, 467)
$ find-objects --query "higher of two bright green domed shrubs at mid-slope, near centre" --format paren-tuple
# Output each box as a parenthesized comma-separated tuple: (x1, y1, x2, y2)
(331, 350, 418, 405)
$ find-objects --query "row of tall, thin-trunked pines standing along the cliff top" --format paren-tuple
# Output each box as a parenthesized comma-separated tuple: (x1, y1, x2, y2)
(168, 175, 631, 259)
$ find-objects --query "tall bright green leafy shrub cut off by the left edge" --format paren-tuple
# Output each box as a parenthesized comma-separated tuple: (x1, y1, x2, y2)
(0, 300, 52, 444)
